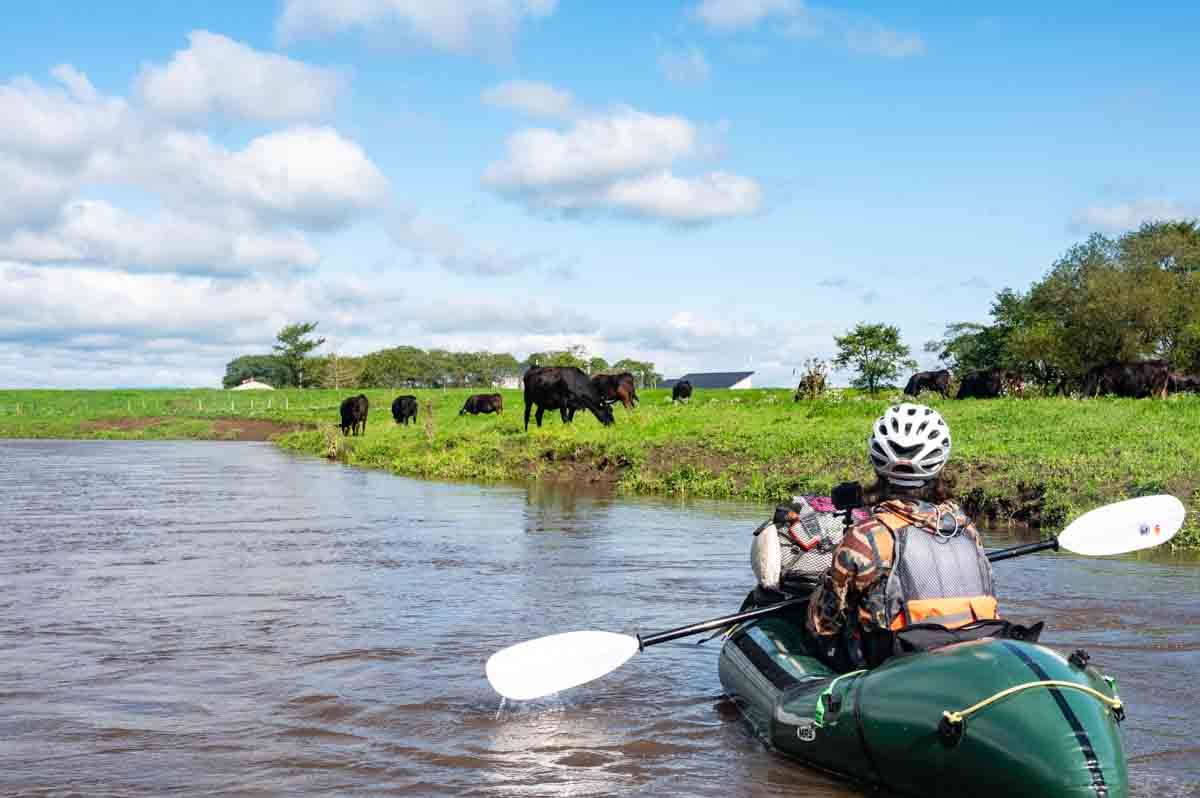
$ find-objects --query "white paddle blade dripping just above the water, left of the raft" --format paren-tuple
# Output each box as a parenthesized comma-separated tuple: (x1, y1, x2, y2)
(487, 631, 638, 701)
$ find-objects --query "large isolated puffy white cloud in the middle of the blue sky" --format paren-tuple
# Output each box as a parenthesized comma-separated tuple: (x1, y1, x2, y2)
(482, 101, 762, 223)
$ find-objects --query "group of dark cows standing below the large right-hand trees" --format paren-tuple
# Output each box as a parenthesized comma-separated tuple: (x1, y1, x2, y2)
(904, 360, 1200, 398)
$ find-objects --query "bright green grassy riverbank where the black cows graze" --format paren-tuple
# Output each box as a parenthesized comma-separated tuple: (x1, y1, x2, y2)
(0, 390, 1200, 545)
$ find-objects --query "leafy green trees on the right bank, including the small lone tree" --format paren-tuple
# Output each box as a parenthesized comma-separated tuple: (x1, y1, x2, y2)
(834, 220, 1200, 392)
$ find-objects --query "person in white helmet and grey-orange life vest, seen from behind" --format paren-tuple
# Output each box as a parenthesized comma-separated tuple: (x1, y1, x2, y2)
(808, 402, 998, 671)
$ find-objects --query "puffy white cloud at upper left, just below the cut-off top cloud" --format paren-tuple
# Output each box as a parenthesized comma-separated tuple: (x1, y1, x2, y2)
(138, 30, 343, 121)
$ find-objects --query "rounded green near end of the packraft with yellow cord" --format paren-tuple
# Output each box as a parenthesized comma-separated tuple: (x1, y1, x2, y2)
(858, 640, 1129, 798)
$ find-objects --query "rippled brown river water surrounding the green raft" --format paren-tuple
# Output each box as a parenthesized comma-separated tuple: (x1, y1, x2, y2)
(0, 440, 1200, 798)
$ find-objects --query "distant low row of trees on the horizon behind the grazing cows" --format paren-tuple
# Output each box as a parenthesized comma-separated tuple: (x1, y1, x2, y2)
(222, 322, 662, 389)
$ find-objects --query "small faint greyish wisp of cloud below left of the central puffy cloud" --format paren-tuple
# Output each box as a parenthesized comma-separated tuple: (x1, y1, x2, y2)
(388, 210, 564, 277)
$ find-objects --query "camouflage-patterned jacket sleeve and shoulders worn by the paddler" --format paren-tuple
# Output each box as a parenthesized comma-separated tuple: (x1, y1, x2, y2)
(808, 499, 983, 635)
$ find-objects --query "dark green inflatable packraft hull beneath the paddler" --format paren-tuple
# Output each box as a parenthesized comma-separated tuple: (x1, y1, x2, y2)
(720, 617, 1129, 798)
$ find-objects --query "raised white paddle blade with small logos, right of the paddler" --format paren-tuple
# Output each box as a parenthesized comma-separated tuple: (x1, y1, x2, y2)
(1058, 496, 1184, 557)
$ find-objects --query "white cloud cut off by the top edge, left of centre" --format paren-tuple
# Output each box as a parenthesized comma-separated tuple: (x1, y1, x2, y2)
(276, 0, 558, 53)
